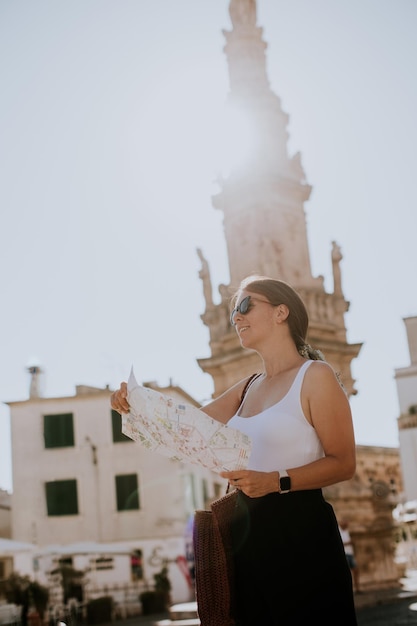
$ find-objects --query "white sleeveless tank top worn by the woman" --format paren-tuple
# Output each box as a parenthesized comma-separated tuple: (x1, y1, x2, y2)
(227, 361, 324, 472)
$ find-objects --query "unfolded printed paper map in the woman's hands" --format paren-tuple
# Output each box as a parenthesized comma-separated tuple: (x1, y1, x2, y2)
(122, 369, 251, 473)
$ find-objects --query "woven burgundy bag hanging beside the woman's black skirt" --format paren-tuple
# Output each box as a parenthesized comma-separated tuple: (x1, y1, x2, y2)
(193, 490, 239, 626)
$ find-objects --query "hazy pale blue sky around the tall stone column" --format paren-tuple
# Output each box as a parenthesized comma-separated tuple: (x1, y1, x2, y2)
(0, 0, 417, 490)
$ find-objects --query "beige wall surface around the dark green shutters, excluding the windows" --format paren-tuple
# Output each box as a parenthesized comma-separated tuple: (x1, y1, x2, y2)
(10, 390, 224, 546)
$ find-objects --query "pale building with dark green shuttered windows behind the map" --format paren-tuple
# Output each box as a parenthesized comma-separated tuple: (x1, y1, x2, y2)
(5, 383, 226, 602)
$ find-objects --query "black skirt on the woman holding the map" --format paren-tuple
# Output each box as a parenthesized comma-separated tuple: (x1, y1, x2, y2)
(232, 489, 357, 626)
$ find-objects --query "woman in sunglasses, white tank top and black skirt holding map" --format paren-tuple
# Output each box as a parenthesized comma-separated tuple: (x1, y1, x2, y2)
(112, 276, 357, 626)
